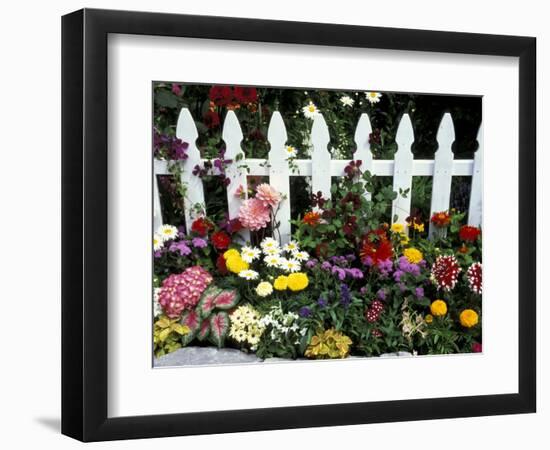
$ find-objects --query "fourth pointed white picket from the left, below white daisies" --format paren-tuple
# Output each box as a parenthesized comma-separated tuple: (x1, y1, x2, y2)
(311, 114, 331, 199)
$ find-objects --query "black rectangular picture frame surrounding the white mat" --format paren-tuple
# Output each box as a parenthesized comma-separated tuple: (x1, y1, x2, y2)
(62, 9, 536, 441)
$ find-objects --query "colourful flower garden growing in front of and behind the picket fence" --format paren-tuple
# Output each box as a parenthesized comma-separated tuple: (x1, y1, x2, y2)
(153, 84, 482, 366)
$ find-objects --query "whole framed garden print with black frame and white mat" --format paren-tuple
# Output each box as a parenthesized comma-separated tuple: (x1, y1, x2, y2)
(62, 9, 536, 441)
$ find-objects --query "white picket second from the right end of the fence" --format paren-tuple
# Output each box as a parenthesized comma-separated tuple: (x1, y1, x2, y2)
(429, 113, 455, 237)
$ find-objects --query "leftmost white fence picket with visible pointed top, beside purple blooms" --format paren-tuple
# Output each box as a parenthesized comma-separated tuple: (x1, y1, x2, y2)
(176, 108, 206, 232)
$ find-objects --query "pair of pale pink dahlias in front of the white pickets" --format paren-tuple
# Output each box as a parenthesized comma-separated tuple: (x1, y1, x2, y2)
(239, 183, 281, 231)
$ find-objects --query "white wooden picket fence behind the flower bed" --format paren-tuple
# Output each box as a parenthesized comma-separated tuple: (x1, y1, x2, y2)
(153, 108, 483, 243)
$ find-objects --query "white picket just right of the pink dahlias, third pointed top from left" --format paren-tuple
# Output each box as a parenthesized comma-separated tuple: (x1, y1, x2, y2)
(267, 111, 290, 245)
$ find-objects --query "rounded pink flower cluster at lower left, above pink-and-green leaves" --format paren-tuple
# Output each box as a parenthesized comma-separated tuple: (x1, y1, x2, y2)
(158, 266, 212, 319)
